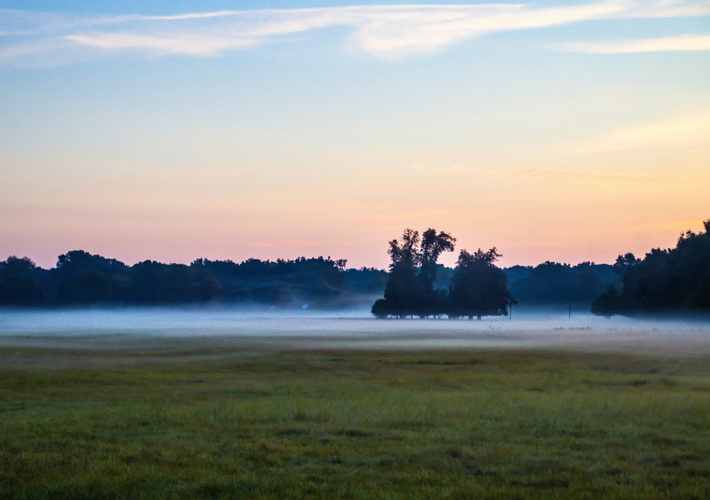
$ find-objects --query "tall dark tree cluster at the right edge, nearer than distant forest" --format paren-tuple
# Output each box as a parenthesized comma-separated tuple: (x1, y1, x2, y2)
(591, 220, 710, 316)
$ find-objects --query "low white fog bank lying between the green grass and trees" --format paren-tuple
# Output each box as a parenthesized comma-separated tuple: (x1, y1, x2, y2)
(0, 307, 710, 355)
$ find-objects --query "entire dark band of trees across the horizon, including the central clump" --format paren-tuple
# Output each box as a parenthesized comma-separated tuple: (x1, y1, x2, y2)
(0, 220, 710, 317)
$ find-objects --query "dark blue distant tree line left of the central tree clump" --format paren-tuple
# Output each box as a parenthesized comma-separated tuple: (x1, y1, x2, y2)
(0, 250, 364, 306)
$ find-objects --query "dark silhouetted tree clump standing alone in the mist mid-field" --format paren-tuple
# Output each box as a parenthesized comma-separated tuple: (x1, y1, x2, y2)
(372, 228, 515, 319)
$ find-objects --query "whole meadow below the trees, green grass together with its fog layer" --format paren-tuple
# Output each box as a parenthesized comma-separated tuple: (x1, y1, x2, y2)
(0, 308, 710, 499)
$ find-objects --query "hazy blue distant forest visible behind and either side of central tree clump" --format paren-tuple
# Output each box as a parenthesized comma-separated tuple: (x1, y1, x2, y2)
(0, 245, 620, 309)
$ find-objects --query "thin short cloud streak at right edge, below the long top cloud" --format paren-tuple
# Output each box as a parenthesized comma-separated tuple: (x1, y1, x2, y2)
(558, 35, 710, 54)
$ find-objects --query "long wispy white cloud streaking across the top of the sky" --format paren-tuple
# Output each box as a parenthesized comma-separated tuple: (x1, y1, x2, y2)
(0, 0, 710, 65)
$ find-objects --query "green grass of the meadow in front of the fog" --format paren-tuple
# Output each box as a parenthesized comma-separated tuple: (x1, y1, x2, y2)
(0, 346, 710, 500)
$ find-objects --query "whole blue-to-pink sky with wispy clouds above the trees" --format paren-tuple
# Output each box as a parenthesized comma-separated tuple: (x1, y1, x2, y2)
(0, 0, 710, 268)
